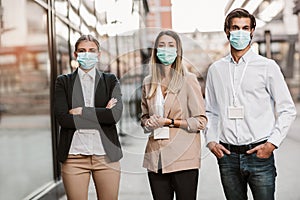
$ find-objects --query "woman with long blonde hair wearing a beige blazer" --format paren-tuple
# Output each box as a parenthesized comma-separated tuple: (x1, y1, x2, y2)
(141, 31, 207, 200)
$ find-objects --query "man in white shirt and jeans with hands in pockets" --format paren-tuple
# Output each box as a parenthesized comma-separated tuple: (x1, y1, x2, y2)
(205, 8, 296, 200)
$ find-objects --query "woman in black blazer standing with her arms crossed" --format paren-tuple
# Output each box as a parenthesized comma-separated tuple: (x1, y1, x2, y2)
(54, 35, 123, 200)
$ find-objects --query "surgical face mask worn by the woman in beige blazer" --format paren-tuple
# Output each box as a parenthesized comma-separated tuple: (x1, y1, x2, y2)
(156, 47, 177, 65)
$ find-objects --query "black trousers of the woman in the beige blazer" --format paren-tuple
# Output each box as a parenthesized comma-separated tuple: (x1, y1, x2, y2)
(148, 169, 199, 200)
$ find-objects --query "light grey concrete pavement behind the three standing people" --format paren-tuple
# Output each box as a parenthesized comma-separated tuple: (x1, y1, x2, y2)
(60, 103, 300, 200)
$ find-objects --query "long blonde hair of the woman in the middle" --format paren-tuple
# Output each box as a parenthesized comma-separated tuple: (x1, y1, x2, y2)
(146, 30, 185, 98)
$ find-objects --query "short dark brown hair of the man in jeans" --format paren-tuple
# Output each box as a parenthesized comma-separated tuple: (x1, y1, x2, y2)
(224, 8, 256, 32)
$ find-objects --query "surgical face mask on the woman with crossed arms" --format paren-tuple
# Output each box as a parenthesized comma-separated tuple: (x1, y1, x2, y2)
(77, 52, 99, 69)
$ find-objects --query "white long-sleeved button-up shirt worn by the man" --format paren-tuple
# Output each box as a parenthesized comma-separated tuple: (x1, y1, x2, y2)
(205, 49, 296, 147)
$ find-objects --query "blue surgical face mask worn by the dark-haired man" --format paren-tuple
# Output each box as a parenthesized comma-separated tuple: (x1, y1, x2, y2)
(229, 30, 251, 50)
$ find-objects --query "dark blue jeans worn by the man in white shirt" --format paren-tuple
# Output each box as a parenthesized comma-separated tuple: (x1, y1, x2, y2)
(218, 152, 276, 200)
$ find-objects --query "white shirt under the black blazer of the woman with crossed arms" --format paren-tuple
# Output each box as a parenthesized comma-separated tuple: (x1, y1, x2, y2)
(69, 68, 105, 155)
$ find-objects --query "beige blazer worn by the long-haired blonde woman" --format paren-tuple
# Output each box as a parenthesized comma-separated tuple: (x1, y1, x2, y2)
(141, 73, 207, 173)
